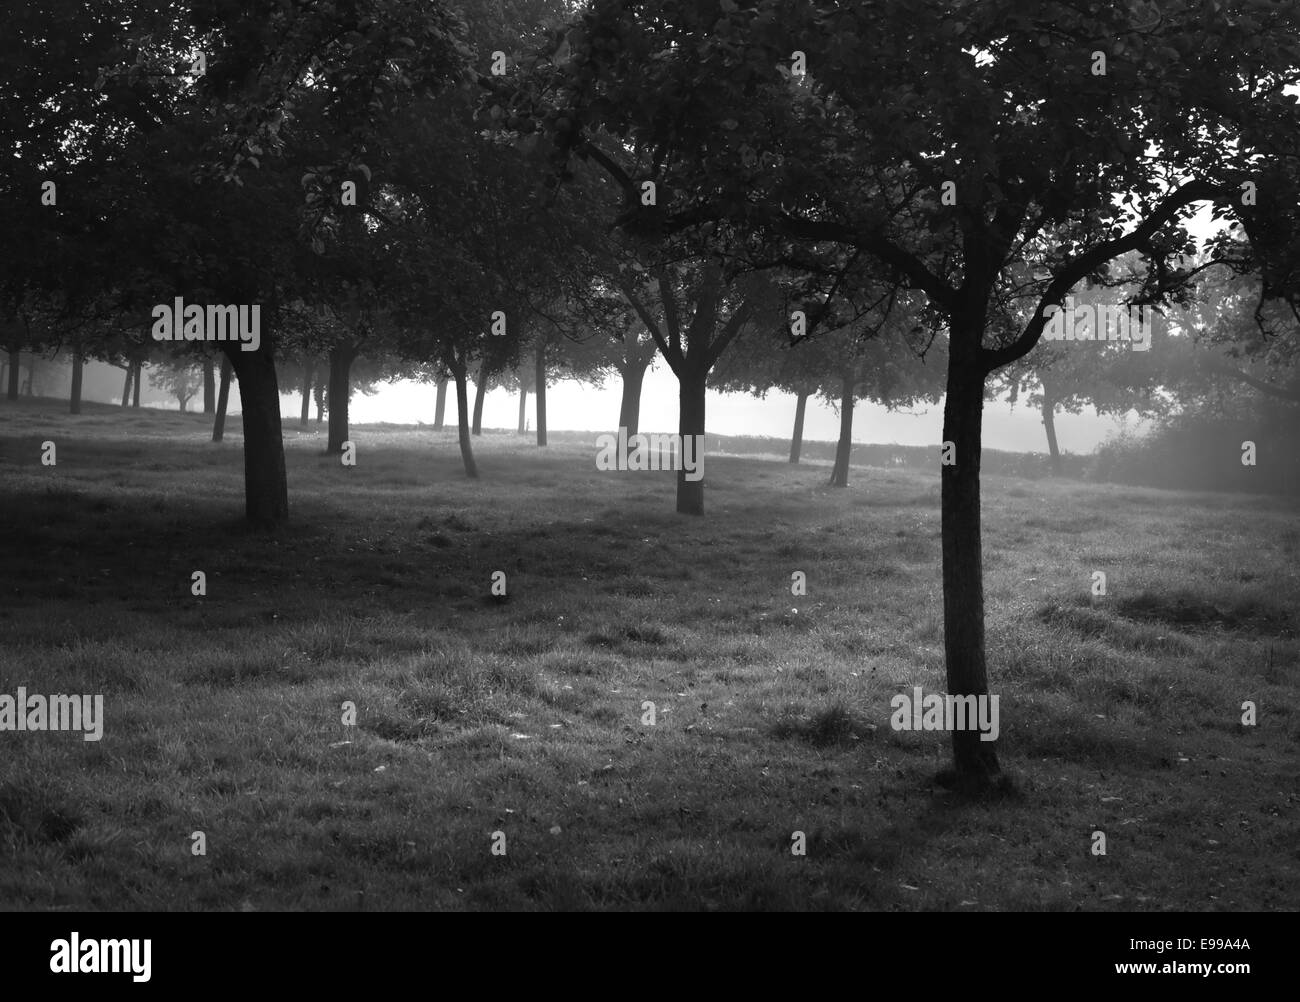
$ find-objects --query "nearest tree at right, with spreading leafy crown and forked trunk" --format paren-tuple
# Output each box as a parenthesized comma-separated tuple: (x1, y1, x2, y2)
(508, 0, 1300, 786)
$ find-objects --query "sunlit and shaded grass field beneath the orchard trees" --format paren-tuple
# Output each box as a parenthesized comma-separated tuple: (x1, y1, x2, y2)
(0, 402, 1300, 911)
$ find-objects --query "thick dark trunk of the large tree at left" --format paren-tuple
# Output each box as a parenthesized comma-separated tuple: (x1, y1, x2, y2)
(226, 340, 289, 529)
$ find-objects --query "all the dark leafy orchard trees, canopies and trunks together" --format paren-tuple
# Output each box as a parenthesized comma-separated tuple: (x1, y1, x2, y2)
(0, 0, 1300, 782)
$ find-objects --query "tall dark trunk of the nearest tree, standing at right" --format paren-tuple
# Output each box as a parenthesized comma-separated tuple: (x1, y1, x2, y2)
(940, 324, 1000, 785)
